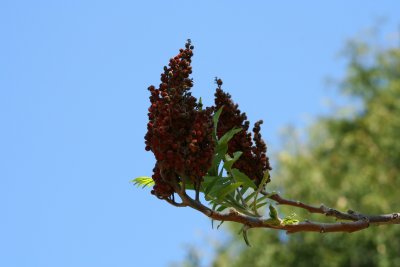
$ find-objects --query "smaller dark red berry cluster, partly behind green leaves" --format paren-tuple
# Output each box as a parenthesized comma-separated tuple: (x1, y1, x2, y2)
(215, 78, 271, 184)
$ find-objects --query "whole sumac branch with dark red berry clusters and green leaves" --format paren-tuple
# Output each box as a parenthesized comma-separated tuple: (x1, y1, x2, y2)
(133, 40, 400, 244)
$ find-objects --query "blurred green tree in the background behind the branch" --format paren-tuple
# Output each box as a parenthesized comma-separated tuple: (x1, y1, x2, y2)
(181, 34, 400, 267)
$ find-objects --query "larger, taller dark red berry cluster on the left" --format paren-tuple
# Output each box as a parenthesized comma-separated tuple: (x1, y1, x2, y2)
(145, 40, 215, 198)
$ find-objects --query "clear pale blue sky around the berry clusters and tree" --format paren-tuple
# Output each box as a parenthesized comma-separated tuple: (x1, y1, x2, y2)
(0, 0, 400, 267)
